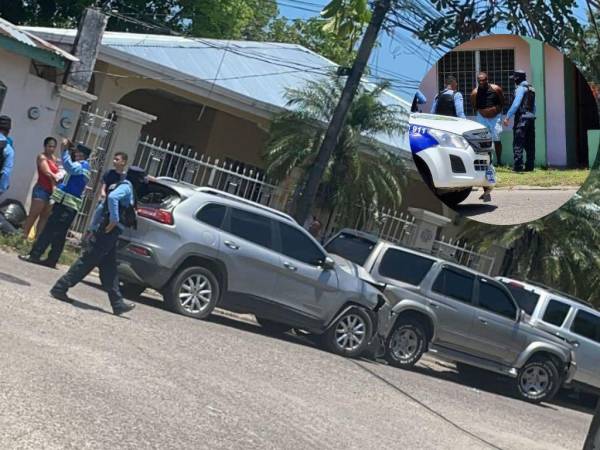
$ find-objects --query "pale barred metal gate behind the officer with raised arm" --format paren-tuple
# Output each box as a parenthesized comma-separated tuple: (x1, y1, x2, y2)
(70, 109, 115, 239)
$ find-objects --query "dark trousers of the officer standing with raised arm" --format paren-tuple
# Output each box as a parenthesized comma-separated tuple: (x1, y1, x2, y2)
(29, 204, 77, 265)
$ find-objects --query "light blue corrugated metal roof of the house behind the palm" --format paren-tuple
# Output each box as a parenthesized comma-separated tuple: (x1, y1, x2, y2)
(24, 27, 410, 149)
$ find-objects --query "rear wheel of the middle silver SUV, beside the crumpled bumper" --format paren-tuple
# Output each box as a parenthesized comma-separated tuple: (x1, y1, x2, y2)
(385, 319, 428, 369)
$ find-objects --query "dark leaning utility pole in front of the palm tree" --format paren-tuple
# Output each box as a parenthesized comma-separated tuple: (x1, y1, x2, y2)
(294, 0, 392, 224)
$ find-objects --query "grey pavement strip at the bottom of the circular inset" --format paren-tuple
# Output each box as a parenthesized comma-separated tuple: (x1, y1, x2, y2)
(455, 189, 577, 225)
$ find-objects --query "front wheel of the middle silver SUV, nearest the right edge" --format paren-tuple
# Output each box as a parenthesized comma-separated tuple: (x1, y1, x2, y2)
(516, 357, 560, 403)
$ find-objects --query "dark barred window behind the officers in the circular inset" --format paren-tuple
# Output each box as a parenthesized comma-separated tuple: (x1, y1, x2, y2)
(437, 49, 515, 116)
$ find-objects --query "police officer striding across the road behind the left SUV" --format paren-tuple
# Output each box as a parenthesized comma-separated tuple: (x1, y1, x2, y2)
(50, 167, 147, 315)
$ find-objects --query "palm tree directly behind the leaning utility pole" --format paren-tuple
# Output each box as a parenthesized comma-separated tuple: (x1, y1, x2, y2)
(264, 77, 408, 225)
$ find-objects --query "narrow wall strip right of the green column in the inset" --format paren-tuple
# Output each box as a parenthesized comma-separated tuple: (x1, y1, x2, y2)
(544, 45, 567, 166)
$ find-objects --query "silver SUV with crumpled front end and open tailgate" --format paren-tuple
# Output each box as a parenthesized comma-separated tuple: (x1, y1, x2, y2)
(118, 178, 389, 357)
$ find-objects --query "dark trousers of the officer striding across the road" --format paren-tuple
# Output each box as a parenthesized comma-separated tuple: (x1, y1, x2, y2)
(53, 228, 123, 307)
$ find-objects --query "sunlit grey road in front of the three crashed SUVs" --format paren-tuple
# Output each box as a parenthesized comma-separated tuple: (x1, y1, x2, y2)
(0, 253, 591, 450)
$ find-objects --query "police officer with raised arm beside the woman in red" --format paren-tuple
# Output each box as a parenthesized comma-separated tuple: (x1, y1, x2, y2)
(19, 139, 92, 268)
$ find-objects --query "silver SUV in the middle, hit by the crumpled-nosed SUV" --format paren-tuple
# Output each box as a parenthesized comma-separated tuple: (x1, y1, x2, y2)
(325, 230, 575, 402)
